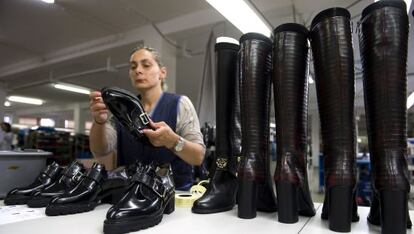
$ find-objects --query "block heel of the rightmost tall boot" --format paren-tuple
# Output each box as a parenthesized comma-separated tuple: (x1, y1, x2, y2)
(379, 190, 408, 234)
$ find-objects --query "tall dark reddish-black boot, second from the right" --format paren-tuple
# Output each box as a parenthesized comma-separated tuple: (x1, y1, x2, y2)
(311, 8, 359, 232)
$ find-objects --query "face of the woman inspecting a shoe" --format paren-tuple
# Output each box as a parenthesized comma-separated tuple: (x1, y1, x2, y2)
(129, 49, 167, 92)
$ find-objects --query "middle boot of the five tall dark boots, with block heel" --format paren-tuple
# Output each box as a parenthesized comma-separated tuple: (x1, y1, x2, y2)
(273, 23, 315, 223)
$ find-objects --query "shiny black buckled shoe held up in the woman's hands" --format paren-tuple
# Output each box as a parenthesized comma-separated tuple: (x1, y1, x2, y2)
(101, 87, 151, 143)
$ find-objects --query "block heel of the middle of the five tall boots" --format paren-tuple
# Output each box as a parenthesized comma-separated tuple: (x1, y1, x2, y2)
(276, 182, 299, 223)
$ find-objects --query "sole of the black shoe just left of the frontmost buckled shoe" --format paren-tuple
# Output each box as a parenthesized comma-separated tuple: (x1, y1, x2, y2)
(45, 202, 98, 216)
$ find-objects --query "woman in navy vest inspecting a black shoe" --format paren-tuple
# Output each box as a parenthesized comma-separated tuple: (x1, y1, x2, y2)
(90, 47, 205, 190)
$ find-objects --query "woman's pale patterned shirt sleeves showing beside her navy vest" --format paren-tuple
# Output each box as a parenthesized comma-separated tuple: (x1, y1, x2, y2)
(92, 96, 205, 155)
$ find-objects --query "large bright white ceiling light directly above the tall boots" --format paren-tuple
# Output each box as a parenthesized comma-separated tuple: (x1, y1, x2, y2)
(206, 0, 272, 37)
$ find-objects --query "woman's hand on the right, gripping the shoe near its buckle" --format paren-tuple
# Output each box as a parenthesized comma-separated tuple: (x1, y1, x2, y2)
(143, 121, 180, 149)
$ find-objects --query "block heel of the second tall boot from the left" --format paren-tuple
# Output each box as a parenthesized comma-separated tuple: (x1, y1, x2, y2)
(237, 180, 257, 219)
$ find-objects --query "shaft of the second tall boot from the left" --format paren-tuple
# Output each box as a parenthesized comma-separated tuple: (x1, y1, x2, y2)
(238, 33, 272, 180)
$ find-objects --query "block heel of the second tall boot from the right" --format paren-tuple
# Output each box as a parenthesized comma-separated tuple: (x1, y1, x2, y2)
(328, 186, 353, 232)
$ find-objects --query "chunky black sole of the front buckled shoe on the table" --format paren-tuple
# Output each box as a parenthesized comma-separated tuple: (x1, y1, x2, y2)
(103, 196, 175, 234)
